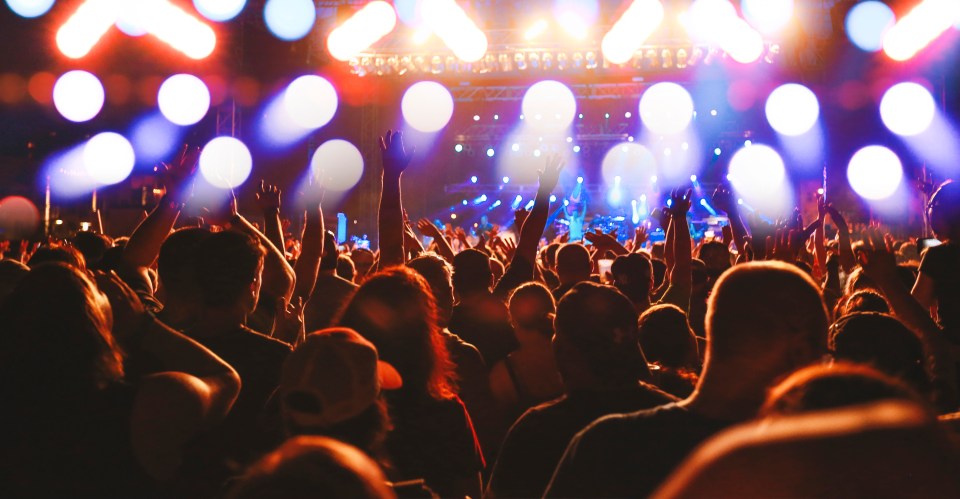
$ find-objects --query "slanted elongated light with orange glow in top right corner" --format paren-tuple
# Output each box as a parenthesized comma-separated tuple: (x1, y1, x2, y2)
(883, 0, 960, 61)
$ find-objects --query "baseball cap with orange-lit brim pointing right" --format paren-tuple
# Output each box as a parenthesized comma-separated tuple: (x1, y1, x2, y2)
(280, 327, 403, 427)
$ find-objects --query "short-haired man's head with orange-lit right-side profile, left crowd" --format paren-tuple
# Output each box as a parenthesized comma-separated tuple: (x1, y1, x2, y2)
(196, 231, 265, 313)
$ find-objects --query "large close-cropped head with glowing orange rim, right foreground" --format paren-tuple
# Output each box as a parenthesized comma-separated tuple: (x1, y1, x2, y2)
(698, 261, 829, 401)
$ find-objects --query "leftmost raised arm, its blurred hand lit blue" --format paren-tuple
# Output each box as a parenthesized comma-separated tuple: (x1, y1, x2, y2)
(121, 147, 200, 269)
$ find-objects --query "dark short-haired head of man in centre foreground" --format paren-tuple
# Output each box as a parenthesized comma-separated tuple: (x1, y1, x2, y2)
(553, 282, 650, 391)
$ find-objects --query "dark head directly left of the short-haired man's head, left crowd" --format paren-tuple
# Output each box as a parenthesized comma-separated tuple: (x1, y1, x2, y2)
(157, 227, 212, 306)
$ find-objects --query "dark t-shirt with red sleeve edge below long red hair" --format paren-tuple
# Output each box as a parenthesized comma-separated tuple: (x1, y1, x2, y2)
(386, 392, 485, 497)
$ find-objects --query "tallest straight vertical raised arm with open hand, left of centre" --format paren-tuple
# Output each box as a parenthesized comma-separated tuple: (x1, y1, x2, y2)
(377, 130, 413, 268)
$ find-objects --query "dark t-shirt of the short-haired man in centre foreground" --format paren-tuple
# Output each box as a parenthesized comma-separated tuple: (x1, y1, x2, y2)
(487, 383, 677, 497)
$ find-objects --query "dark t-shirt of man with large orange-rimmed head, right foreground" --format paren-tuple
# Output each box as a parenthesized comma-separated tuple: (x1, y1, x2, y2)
(545, 404, 731, 497)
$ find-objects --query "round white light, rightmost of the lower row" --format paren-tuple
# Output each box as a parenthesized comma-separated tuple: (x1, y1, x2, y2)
(847, 146, 903, 200)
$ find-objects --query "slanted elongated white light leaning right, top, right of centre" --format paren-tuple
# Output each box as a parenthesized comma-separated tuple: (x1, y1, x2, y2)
(600, 0, 663, 64)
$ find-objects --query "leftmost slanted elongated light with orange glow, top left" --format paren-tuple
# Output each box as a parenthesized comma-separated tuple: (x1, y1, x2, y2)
(57, 0, 122, 59)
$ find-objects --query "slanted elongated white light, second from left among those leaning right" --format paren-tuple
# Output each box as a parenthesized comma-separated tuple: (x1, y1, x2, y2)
(327, 0, 396, 61)
